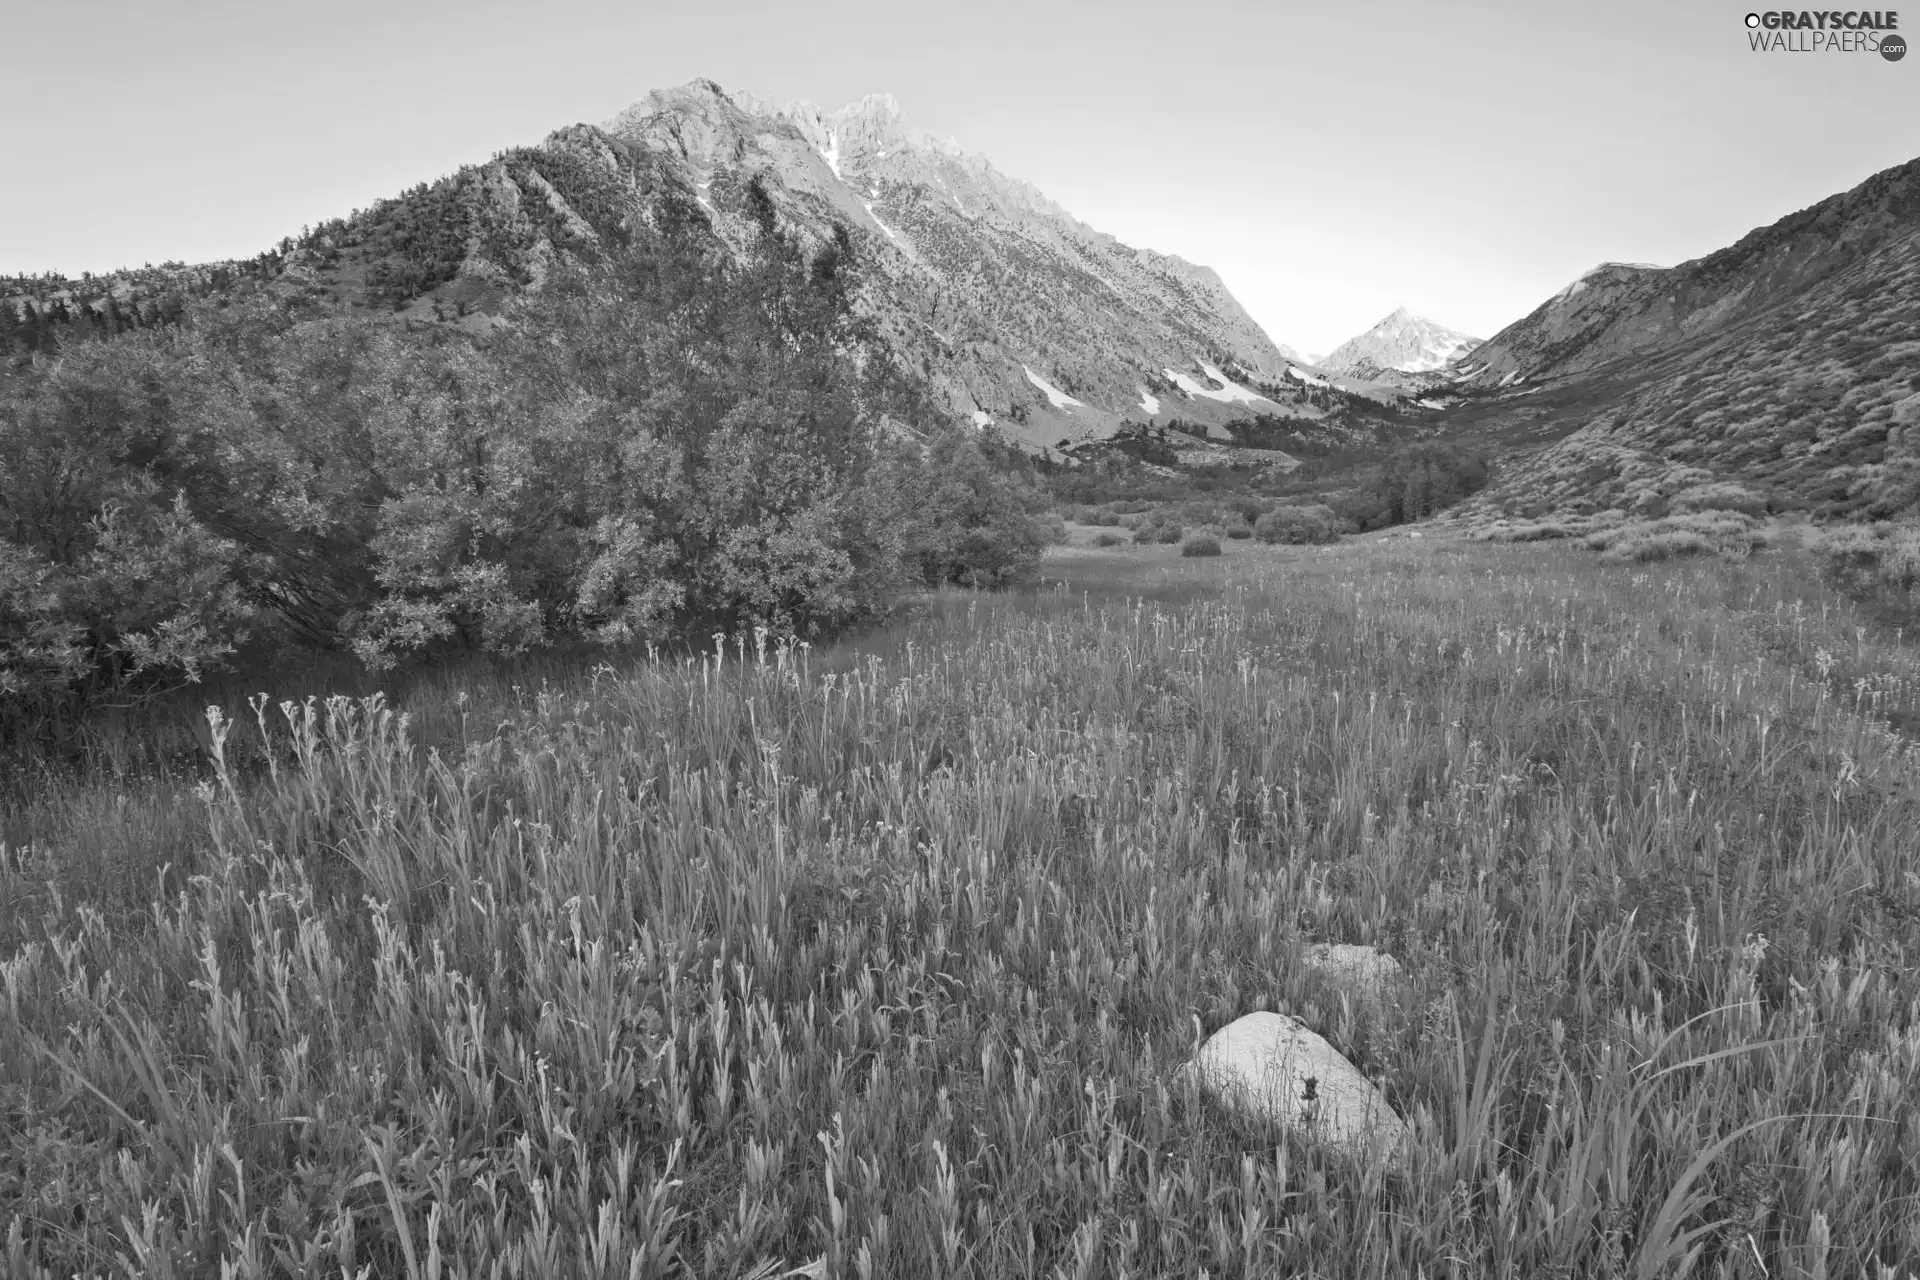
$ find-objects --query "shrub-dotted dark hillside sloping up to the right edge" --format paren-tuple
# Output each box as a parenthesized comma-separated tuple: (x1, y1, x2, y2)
(1450, 159, 1920, 520)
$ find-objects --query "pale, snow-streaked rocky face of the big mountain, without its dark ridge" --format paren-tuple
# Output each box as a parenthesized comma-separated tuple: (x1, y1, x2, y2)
(601, 81, 1300, 445)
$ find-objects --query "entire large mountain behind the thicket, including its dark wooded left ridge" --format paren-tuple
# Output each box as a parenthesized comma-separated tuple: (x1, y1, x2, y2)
(0, 81, 1317, 460)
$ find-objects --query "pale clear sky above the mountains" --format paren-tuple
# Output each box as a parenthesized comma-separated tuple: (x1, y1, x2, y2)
(0, 0, 1920, 353)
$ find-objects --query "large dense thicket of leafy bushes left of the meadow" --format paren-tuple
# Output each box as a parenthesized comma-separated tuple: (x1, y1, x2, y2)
(0, 192, 1043, 736)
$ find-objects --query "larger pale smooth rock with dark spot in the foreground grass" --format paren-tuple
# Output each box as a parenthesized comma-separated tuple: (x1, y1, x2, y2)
(1181, 1013, 1409, 1163)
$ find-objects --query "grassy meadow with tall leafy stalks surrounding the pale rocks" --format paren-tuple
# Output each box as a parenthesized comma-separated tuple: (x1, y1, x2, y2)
(0, 539, 1920, 1280)
